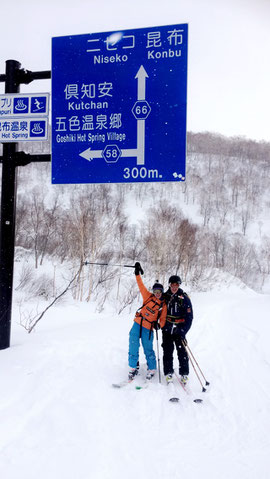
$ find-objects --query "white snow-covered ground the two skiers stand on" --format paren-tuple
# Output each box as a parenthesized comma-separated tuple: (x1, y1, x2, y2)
(0, 286, 270, 479)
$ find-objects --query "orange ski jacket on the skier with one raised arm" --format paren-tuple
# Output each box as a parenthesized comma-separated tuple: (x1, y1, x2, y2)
(134, 275, 167, 329)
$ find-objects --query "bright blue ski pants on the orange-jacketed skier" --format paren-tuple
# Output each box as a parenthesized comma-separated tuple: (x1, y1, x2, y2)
(128, 321, 157, 369)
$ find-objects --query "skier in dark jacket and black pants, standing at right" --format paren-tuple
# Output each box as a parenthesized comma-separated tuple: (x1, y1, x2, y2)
(162, 275, 193, 385)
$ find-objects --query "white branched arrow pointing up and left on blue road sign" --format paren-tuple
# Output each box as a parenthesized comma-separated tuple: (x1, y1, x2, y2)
(79, 65, 149, 165)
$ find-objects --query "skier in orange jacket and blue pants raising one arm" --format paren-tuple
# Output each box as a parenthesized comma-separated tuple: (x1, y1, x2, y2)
(128, 262, 167, 379)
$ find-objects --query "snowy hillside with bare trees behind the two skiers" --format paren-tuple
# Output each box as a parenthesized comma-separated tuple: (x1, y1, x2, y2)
(0, 132, 270, 308)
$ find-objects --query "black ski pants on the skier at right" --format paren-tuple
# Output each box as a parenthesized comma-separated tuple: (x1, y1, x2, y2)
(162, 330, 189, 376)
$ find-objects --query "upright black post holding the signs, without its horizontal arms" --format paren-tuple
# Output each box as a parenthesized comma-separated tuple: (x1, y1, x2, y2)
(0, 60, 21, 349)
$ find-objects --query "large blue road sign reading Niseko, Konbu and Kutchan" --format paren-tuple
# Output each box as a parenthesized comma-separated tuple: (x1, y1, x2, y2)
(52, 24, 188, 183)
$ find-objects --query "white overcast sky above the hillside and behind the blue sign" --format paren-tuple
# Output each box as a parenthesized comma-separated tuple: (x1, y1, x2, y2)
(0, 0, 270, 141)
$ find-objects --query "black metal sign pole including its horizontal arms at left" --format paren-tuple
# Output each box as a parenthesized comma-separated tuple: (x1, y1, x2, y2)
(0, 60, 51, 350)
